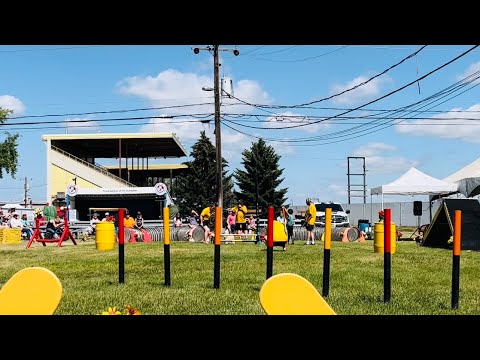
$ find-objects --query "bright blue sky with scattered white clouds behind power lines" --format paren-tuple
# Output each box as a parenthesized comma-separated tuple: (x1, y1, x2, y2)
(0, 44, 480, 205)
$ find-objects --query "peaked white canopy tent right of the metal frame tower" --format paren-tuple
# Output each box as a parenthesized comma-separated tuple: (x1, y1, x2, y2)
(370, 167, 458, 208)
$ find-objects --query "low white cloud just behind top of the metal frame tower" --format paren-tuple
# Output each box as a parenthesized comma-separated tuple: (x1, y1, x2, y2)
(350, 143, 418, 174)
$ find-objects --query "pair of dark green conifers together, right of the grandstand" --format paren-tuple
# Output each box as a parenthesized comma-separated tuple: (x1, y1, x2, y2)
(174, 131, 288, 218)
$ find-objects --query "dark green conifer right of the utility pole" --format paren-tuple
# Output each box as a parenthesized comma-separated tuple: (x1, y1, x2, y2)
(233, 139, 288, 217)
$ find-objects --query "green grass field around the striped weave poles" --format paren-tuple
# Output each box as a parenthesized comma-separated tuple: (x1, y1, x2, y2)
(0, 233, 480, 315)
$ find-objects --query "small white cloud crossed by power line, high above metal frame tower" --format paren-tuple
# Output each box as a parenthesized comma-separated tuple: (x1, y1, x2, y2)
(329, 75, 391, 105)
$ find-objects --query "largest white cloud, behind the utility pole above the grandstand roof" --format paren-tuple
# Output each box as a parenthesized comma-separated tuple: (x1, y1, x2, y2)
(116, 69, 272, 161)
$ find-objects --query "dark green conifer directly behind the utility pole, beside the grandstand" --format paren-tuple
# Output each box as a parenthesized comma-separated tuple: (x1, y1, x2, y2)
(176, 131, 233, 216)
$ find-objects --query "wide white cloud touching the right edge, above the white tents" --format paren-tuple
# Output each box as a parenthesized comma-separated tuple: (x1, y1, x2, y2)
(395, 104, 480, 143)
